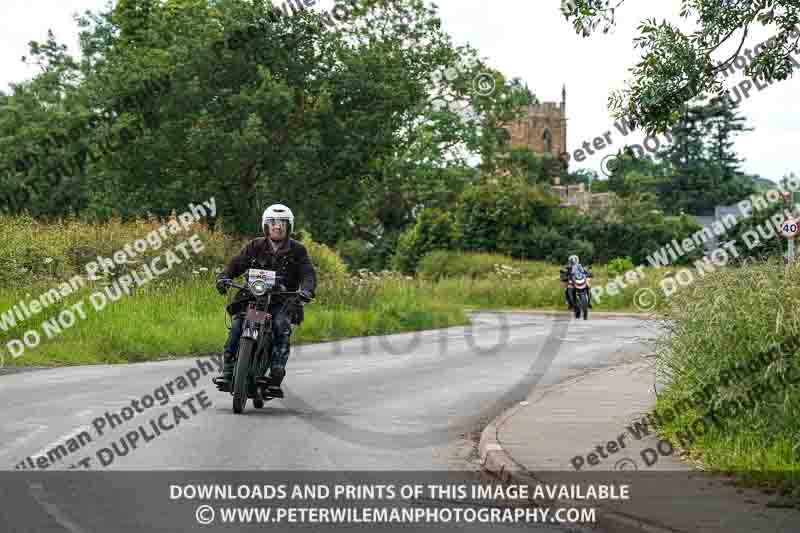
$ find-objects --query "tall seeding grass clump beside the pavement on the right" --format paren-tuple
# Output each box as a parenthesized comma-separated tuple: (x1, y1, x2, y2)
(656, 262, 800, 496)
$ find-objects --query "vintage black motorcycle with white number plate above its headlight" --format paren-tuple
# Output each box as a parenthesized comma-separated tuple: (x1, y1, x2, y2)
(212, 268, 305, 414)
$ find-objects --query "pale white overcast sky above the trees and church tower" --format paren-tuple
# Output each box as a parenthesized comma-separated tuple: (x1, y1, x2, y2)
(0, 0, 800, 180)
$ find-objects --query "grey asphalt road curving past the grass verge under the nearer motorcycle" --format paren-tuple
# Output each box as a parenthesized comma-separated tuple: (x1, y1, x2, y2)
(0, 313, 657, 533)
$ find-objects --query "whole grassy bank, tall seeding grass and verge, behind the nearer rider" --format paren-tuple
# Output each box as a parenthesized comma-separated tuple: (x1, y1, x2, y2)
(0, 217, 467, 366)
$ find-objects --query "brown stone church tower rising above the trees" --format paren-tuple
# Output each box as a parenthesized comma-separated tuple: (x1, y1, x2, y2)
(506, 86, 567, 158)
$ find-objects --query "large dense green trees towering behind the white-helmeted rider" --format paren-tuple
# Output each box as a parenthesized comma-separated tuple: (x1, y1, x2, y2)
(0, 0, 532, 243)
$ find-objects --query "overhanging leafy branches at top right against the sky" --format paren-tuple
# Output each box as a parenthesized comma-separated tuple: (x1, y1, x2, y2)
(562, 0, 800, 133)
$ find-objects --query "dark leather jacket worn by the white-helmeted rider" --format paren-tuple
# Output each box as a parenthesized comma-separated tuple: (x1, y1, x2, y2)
(217, 237, 317, 324)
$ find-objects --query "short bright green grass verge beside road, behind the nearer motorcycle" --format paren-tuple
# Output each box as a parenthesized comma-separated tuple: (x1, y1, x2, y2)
(0, 275, 467, 366)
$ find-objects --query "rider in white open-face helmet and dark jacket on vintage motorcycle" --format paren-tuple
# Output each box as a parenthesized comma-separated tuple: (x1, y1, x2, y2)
(214, 204, 317, 397)
